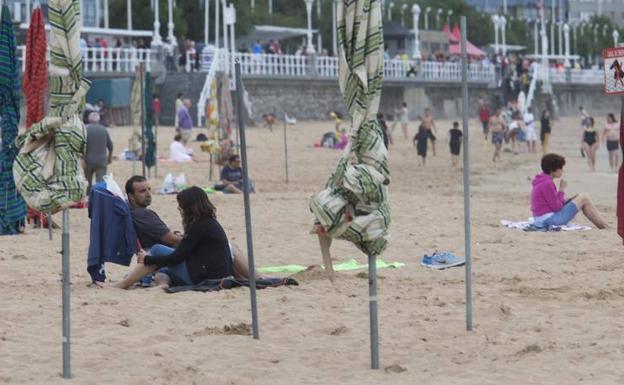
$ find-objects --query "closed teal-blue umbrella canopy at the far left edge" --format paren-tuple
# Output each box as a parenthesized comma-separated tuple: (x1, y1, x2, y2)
(0, 5, 26, 234)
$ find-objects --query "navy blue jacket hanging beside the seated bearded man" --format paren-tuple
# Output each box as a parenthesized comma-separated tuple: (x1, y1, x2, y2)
(87, 182, 137, 282)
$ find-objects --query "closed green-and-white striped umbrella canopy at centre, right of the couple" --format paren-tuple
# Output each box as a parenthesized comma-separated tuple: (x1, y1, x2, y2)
(310, 0, 390, 255)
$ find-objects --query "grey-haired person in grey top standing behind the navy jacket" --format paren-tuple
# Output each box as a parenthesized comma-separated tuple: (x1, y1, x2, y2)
(84, 112, 113, 195)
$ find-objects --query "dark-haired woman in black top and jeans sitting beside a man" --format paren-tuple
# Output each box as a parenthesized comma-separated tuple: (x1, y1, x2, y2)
(116, 186, 234, 289)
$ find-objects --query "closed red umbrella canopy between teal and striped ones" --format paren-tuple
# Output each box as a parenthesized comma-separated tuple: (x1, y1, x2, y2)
(24, 7, 48, 129)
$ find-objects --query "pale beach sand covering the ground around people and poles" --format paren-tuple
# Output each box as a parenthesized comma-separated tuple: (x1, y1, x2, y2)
(0, 118, 624, 385)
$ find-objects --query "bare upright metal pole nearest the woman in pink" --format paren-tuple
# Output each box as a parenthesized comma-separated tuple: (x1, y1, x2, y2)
(461, 16, 472, 331)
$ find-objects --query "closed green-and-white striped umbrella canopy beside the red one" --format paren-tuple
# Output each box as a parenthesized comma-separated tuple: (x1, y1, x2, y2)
(13, 0, 91, 212)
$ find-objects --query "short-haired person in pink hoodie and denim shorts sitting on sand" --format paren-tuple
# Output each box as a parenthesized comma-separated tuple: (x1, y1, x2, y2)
(531, 154, 607, 229)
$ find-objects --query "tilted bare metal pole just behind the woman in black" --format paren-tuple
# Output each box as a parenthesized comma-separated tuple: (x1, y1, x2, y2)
(234, 60, 260, 339)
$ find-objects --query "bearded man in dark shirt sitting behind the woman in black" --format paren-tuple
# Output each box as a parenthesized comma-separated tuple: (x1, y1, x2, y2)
(125, 175, 249, 278)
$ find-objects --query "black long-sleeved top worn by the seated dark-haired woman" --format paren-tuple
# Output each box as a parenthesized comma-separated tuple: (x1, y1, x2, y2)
(145, 217, 234, 283)
